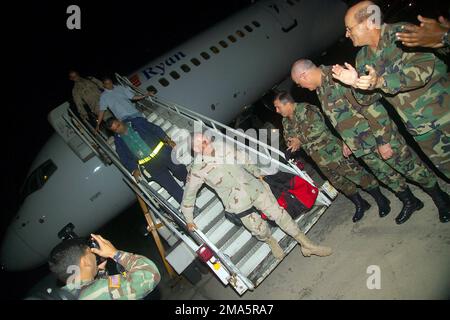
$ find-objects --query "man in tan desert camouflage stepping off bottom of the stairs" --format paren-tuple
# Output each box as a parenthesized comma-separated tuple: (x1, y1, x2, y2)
(181, 133, 332, 260)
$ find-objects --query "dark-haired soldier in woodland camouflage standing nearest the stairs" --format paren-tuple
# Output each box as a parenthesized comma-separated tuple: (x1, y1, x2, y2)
(274, 92, 389, 222)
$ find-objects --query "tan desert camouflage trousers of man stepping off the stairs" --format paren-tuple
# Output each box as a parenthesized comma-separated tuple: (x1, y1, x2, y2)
(241, 182, 301, 241)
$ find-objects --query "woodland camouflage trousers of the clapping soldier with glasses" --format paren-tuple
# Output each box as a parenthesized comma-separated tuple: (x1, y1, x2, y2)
(414, 123, 450, 179)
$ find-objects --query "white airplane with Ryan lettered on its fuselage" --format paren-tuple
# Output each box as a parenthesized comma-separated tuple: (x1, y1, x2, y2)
(1, 0, 346, 271)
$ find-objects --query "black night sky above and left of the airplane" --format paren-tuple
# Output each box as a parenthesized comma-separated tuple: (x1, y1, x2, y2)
(2, 0, 251, 225)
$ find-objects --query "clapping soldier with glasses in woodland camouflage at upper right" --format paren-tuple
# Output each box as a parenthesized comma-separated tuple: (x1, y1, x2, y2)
(333, 1, 450, 222)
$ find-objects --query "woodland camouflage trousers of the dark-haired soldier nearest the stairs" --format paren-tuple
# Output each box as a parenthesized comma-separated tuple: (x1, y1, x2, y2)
(306, 139, 379, 196)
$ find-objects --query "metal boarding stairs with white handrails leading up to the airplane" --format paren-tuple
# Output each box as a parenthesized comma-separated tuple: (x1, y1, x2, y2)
(64, 75, 337, 295)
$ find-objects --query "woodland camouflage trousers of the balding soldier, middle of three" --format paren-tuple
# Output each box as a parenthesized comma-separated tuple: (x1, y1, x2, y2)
(361, 130, 437, 193)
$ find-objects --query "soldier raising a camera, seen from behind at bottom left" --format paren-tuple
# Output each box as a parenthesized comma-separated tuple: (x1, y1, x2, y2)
(49, 235, 161, 300)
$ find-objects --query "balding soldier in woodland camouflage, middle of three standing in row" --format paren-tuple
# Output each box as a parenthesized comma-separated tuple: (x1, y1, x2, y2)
(292, 60, 448, 224)
